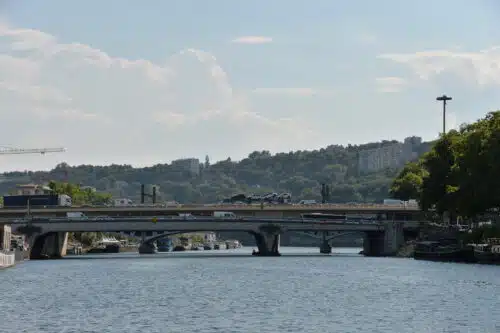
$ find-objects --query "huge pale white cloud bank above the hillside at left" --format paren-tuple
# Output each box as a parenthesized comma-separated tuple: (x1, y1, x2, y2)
(0, 25, 308, 168)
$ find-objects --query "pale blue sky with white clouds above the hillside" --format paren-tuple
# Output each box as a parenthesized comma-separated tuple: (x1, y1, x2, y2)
(0, 0, 500, 170)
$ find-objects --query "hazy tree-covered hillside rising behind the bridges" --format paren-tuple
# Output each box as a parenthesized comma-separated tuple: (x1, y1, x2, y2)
(0, 137, 430, 203)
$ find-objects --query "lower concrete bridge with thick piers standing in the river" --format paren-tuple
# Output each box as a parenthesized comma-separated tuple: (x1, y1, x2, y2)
(11, 217, 419, 259)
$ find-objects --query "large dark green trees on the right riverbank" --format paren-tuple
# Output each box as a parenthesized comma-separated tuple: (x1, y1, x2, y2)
(390, 111, 500, 221)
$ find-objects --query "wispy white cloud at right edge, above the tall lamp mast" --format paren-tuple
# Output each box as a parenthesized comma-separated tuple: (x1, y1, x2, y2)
(379, 46, 500, 85)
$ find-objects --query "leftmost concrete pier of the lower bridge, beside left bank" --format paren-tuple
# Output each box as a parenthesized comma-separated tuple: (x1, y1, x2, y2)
(28, 232, 68, 260)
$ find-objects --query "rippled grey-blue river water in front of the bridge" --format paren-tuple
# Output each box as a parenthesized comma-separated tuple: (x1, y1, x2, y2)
(0, 248, 500, 333)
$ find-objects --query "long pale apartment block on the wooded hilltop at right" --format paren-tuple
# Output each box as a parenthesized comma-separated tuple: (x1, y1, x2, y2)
(358, 136, 422, 173)
